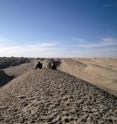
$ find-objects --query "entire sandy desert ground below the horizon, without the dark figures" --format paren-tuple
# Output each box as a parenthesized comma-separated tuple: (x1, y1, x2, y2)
(0, 58, 117, 124)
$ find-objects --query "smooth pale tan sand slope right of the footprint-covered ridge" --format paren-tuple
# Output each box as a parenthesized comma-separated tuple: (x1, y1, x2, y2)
(60, 58, 117, 96)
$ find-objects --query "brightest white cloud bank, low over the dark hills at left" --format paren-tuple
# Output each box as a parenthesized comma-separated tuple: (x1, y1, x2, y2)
(0, 42, 64, 57)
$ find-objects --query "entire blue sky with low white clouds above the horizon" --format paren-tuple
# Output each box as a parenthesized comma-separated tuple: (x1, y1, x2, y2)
(0, 0, 117, 57)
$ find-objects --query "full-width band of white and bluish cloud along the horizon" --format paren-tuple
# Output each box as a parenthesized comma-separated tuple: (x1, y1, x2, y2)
(0, 38, 117, 57)
